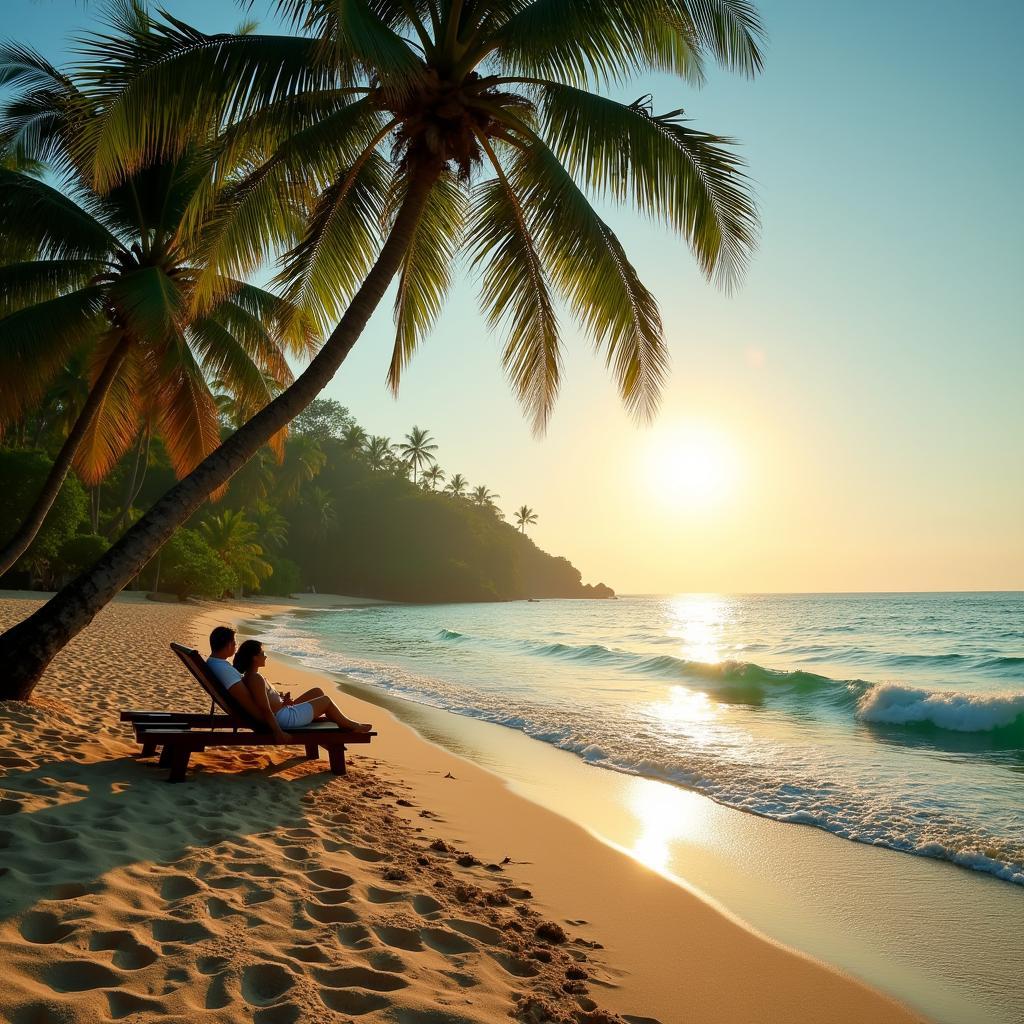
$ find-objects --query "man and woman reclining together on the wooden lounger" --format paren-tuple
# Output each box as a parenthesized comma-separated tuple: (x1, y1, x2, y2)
(206, 626, 372, 742)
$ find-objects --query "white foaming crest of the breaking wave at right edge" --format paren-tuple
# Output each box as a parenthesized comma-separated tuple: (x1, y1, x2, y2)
(857, 683, 1024, 732)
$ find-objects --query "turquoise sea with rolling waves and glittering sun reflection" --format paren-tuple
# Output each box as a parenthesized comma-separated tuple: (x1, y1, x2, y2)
(264, 593, 1024, 885)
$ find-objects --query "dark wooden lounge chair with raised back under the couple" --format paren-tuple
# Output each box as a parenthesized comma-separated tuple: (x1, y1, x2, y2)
(121, 643, 377, 782)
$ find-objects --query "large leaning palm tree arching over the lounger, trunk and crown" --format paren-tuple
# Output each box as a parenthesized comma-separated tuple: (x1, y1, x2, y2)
(0, 0, 762, 696)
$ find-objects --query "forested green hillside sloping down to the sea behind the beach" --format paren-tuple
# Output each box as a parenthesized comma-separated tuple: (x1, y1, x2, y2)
(0, 395, 612, 602)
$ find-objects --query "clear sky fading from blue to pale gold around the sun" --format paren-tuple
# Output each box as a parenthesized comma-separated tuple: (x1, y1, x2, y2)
(9, 0, 1024, 593)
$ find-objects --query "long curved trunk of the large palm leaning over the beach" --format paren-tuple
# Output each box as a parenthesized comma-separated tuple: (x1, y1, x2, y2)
(0, 162, 440, 700)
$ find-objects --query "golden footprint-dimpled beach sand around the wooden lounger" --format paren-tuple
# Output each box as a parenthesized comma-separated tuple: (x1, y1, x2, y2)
(0, 598, 920, 1024)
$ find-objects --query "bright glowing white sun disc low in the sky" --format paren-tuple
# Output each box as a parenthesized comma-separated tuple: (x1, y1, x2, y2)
(647, 424, 739, 509)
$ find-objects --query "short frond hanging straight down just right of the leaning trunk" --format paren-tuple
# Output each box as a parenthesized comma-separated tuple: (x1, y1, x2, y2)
(388, 171, 467, 394)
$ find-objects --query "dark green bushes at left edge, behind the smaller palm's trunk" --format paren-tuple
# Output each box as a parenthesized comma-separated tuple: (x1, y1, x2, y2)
(0, 449, 87, 575)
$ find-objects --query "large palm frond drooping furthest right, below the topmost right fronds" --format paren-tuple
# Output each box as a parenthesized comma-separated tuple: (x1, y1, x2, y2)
(540, 83, 757, 287)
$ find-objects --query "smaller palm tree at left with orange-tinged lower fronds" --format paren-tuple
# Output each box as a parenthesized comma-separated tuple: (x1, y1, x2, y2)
(0, 47, 313, 575)
